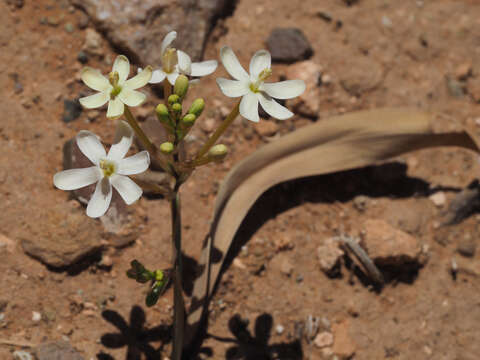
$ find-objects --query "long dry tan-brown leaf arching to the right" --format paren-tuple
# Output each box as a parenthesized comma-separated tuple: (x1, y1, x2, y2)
(186, 109, 479, 344)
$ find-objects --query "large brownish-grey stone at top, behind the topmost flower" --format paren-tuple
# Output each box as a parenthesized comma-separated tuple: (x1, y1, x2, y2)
(72, 0, 236, 66)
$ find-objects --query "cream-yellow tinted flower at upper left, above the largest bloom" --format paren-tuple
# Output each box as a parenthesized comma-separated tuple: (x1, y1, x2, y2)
(80, 55, 152, 118)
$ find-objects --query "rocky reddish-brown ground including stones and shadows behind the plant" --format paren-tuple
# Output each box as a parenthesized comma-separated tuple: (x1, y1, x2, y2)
(0, 0, 480, 360)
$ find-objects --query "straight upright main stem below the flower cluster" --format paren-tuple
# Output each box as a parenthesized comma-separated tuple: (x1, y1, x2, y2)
(170, 183, 185, 360)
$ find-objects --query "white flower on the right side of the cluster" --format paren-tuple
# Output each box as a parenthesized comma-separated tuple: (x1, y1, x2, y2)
(217, 46, 305, 122)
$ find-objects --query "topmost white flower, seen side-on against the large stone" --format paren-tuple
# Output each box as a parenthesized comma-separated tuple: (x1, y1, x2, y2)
(150, 31, 217, 85)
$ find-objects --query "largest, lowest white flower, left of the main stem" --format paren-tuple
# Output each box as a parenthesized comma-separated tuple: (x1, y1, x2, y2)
(53, 121, 150, 218)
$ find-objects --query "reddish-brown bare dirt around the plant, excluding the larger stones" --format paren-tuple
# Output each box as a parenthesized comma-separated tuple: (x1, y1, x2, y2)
(0, 0, 480, 360)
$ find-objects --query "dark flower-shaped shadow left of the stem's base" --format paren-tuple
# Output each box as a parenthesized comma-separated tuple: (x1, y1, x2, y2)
(97, 305, 171, 360)
